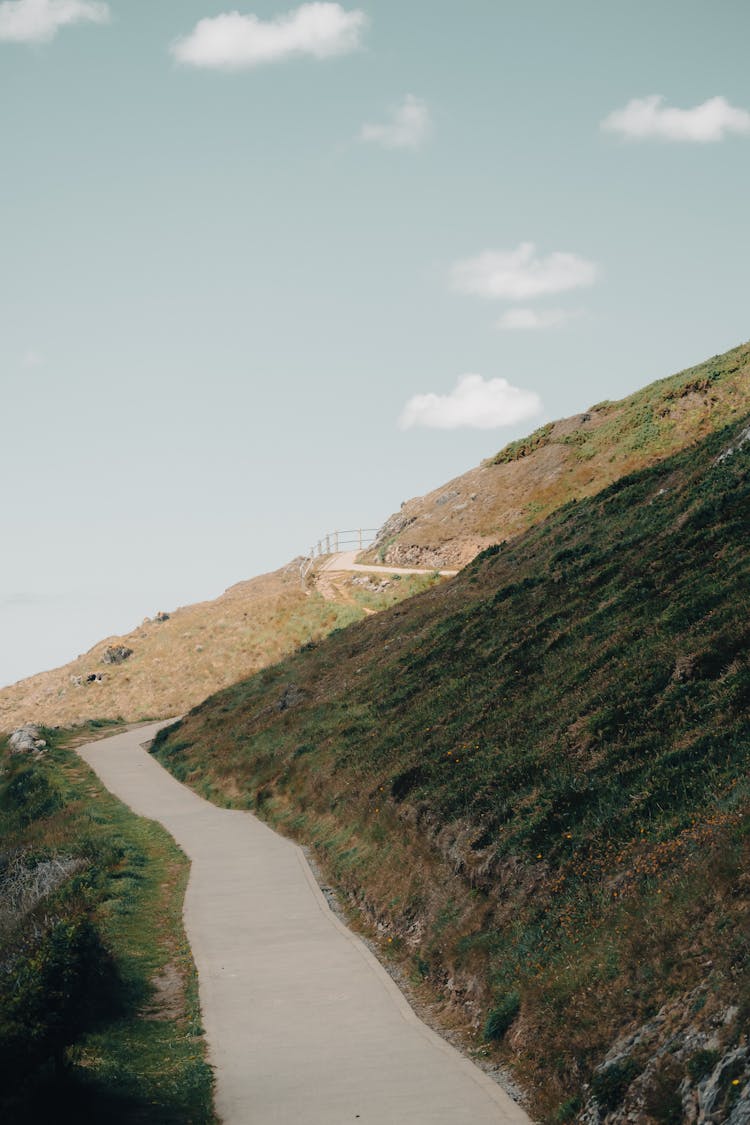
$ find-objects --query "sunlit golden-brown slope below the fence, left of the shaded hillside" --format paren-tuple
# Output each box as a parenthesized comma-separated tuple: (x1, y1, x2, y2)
(0, 563, 433, 730)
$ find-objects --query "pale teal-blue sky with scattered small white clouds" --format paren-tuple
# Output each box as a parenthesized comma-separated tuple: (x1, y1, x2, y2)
(0, 0, 750, 684)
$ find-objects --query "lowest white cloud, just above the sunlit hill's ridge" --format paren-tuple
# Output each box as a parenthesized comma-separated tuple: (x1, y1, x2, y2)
(398, 375, 542, 430)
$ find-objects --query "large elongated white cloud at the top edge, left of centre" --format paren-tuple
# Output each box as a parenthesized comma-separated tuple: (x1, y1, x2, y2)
(171, 2, 368, 70)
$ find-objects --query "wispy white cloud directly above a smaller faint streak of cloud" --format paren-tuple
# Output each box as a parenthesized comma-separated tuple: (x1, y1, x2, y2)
(451, 242, 598, 300)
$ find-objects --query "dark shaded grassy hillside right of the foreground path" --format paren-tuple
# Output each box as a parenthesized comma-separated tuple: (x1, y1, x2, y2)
(157, 416, 750, 1123)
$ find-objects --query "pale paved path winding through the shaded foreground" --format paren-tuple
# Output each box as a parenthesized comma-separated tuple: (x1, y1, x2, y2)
(79, 723, 528, 1125)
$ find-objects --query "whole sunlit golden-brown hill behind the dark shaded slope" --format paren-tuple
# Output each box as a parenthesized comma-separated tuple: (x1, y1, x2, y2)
(0, 344, 750, 730)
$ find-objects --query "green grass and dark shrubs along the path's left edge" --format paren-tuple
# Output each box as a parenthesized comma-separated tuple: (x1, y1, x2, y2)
(0, 722, 215, 1125)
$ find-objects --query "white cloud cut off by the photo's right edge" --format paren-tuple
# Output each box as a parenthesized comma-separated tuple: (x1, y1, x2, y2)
(602, 93, 750, 144)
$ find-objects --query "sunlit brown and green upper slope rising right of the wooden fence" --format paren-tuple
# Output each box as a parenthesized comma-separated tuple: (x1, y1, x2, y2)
(368, 343, 750, 567)
